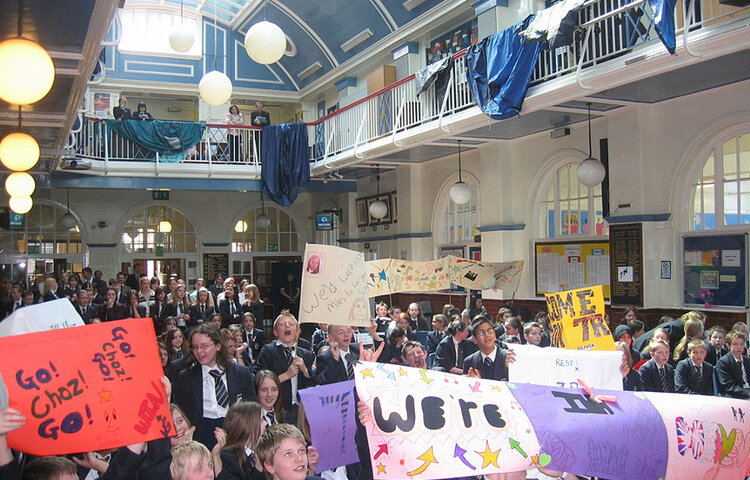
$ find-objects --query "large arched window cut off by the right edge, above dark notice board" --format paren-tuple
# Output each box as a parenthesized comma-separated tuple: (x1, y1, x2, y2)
(689, 133, 750, 230)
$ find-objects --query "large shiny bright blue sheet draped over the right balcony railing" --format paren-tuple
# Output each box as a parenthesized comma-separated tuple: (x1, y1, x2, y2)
(466, 15, 543, 120)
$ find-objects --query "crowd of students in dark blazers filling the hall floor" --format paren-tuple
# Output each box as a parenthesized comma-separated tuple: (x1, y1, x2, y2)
(0, 270, 750, 480)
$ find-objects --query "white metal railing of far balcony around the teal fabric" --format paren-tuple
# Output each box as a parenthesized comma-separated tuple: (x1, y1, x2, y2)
(69, 117, 261, 166)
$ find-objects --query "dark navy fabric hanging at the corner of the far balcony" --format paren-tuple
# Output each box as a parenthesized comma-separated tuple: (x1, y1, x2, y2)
(261, 123, 310, 207)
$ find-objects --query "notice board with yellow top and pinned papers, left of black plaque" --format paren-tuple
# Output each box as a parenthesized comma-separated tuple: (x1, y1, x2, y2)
(534, 240, 610, 298)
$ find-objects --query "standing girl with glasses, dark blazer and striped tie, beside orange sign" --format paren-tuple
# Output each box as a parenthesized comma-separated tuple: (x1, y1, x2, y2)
(172, 323, 258, 448)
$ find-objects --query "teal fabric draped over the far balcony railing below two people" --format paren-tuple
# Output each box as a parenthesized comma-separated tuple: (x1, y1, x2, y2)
(106, 120, 206, 155)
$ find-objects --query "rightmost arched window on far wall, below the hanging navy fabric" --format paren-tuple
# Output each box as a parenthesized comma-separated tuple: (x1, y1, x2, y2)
(232, 205, 302, 253)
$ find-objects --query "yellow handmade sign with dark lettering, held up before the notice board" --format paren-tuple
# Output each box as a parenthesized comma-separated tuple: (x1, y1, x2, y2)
(545, 285, 615, 350)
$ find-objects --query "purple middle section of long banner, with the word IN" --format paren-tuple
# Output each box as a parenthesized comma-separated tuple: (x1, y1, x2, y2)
(511, 383, 669, 480)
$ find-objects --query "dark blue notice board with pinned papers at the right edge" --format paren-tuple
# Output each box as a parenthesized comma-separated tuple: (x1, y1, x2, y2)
(682, 233, 748, 308)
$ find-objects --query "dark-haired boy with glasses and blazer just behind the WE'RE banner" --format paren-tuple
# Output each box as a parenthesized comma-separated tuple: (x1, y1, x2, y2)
(464, 316, 515, 380)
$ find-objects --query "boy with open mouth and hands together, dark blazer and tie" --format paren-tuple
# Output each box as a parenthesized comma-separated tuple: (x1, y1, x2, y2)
(253, 310, 315, 424)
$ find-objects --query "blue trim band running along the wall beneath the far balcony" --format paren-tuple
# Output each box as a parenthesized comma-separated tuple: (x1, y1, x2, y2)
(47, 172, 357, 193)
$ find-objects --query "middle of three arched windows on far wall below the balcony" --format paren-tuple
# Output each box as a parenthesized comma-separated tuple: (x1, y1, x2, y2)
(122, 205, 198, 254)
